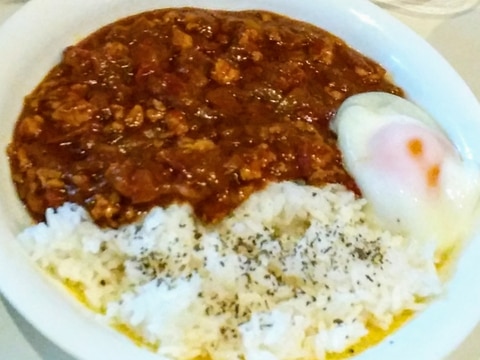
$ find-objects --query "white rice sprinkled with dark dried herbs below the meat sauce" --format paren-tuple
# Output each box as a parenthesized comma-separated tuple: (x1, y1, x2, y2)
(19, 182, 442, 360)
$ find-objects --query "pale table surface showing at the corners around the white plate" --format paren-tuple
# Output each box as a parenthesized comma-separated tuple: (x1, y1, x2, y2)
(0, 0, 480, 360)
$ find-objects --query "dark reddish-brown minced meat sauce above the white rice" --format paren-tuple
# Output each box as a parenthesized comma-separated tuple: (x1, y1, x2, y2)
(8, 8, 402, 227)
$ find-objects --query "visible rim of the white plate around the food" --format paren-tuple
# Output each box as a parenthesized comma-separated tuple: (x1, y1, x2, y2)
(0, 0, 480, 360)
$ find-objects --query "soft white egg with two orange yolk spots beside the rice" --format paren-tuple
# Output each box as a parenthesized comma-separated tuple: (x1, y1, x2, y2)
(331, 92, 480, 254)
